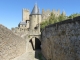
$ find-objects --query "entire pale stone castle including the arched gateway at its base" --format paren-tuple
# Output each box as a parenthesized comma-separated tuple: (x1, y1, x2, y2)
(13, 4, 64, 50)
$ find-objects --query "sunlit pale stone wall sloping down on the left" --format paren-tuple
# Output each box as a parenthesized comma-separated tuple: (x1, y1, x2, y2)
(0, 24, 26, 60)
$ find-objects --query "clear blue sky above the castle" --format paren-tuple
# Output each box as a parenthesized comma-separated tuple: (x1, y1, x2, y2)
(0, 0, 80, 29)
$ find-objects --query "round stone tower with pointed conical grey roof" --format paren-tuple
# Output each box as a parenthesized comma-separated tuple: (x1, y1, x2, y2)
(30, 4, 41, 32)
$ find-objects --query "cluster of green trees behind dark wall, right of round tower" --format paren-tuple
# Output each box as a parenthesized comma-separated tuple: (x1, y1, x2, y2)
(41, 13, 66, 30)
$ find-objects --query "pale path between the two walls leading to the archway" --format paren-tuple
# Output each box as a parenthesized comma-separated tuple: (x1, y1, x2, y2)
(12, 50, 46, 60)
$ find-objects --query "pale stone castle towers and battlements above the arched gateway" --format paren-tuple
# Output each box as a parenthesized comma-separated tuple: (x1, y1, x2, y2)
(12, 4, 66, 34)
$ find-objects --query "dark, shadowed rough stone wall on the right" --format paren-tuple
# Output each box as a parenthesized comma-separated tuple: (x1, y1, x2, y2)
(41, 16, 80, 60)
